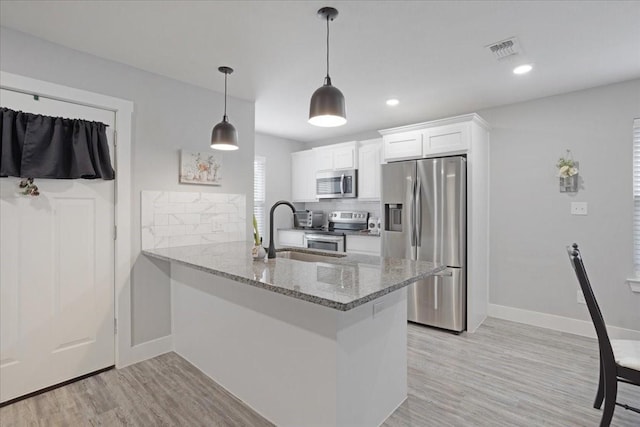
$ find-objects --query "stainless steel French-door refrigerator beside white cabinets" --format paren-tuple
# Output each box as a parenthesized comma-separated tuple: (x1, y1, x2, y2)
(381, 156, 467, 332)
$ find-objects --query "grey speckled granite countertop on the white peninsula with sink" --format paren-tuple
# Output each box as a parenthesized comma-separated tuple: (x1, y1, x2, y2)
(142, 241, 446, 311)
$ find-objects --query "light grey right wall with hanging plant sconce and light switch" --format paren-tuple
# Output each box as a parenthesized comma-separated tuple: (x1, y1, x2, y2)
(478, 80, 640, 330)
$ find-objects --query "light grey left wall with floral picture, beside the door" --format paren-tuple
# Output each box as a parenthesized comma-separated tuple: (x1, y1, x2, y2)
(0, 27, 255, 344)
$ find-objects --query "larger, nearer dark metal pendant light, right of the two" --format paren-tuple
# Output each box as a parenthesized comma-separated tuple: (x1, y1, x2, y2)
(309, 7, 347, 127)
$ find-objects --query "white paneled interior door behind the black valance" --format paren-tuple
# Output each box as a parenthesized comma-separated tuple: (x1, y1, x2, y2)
(0, 89, 115, 402)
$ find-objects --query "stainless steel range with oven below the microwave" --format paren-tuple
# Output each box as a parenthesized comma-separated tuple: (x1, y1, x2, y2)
(304, 211, 369, 252)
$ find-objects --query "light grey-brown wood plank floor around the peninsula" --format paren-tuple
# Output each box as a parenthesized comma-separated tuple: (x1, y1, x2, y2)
(0, 319, 640, 427)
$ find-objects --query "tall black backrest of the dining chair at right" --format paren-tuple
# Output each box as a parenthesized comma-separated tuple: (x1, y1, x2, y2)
(567, 243, 615, 366)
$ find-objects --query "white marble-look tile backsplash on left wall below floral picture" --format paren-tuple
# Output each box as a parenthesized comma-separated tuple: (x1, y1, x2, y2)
(140, 191, 246, 249)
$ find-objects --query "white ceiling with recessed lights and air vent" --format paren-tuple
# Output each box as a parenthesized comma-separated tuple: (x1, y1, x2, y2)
(0, 0, 640, 142)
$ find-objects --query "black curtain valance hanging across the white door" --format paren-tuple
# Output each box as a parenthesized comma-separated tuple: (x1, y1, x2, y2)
(0, 108, 115, 180)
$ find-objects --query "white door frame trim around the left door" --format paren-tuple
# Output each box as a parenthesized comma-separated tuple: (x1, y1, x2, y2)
(0, 71, 139, 368)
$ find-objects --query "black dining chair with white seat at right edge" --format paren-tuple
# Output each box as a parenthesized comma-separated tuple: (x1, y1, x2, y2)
(567, 243, 640, 427)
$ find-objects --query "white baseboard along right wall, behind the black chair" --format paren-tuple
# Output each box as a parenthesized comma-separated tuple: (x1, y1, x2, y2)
(489, 304, 640, 340)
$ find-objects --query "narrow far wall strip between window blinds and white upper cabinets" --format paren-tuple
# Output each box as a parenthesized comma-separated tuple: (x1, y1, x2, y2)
(251, 133, 304, 246)
